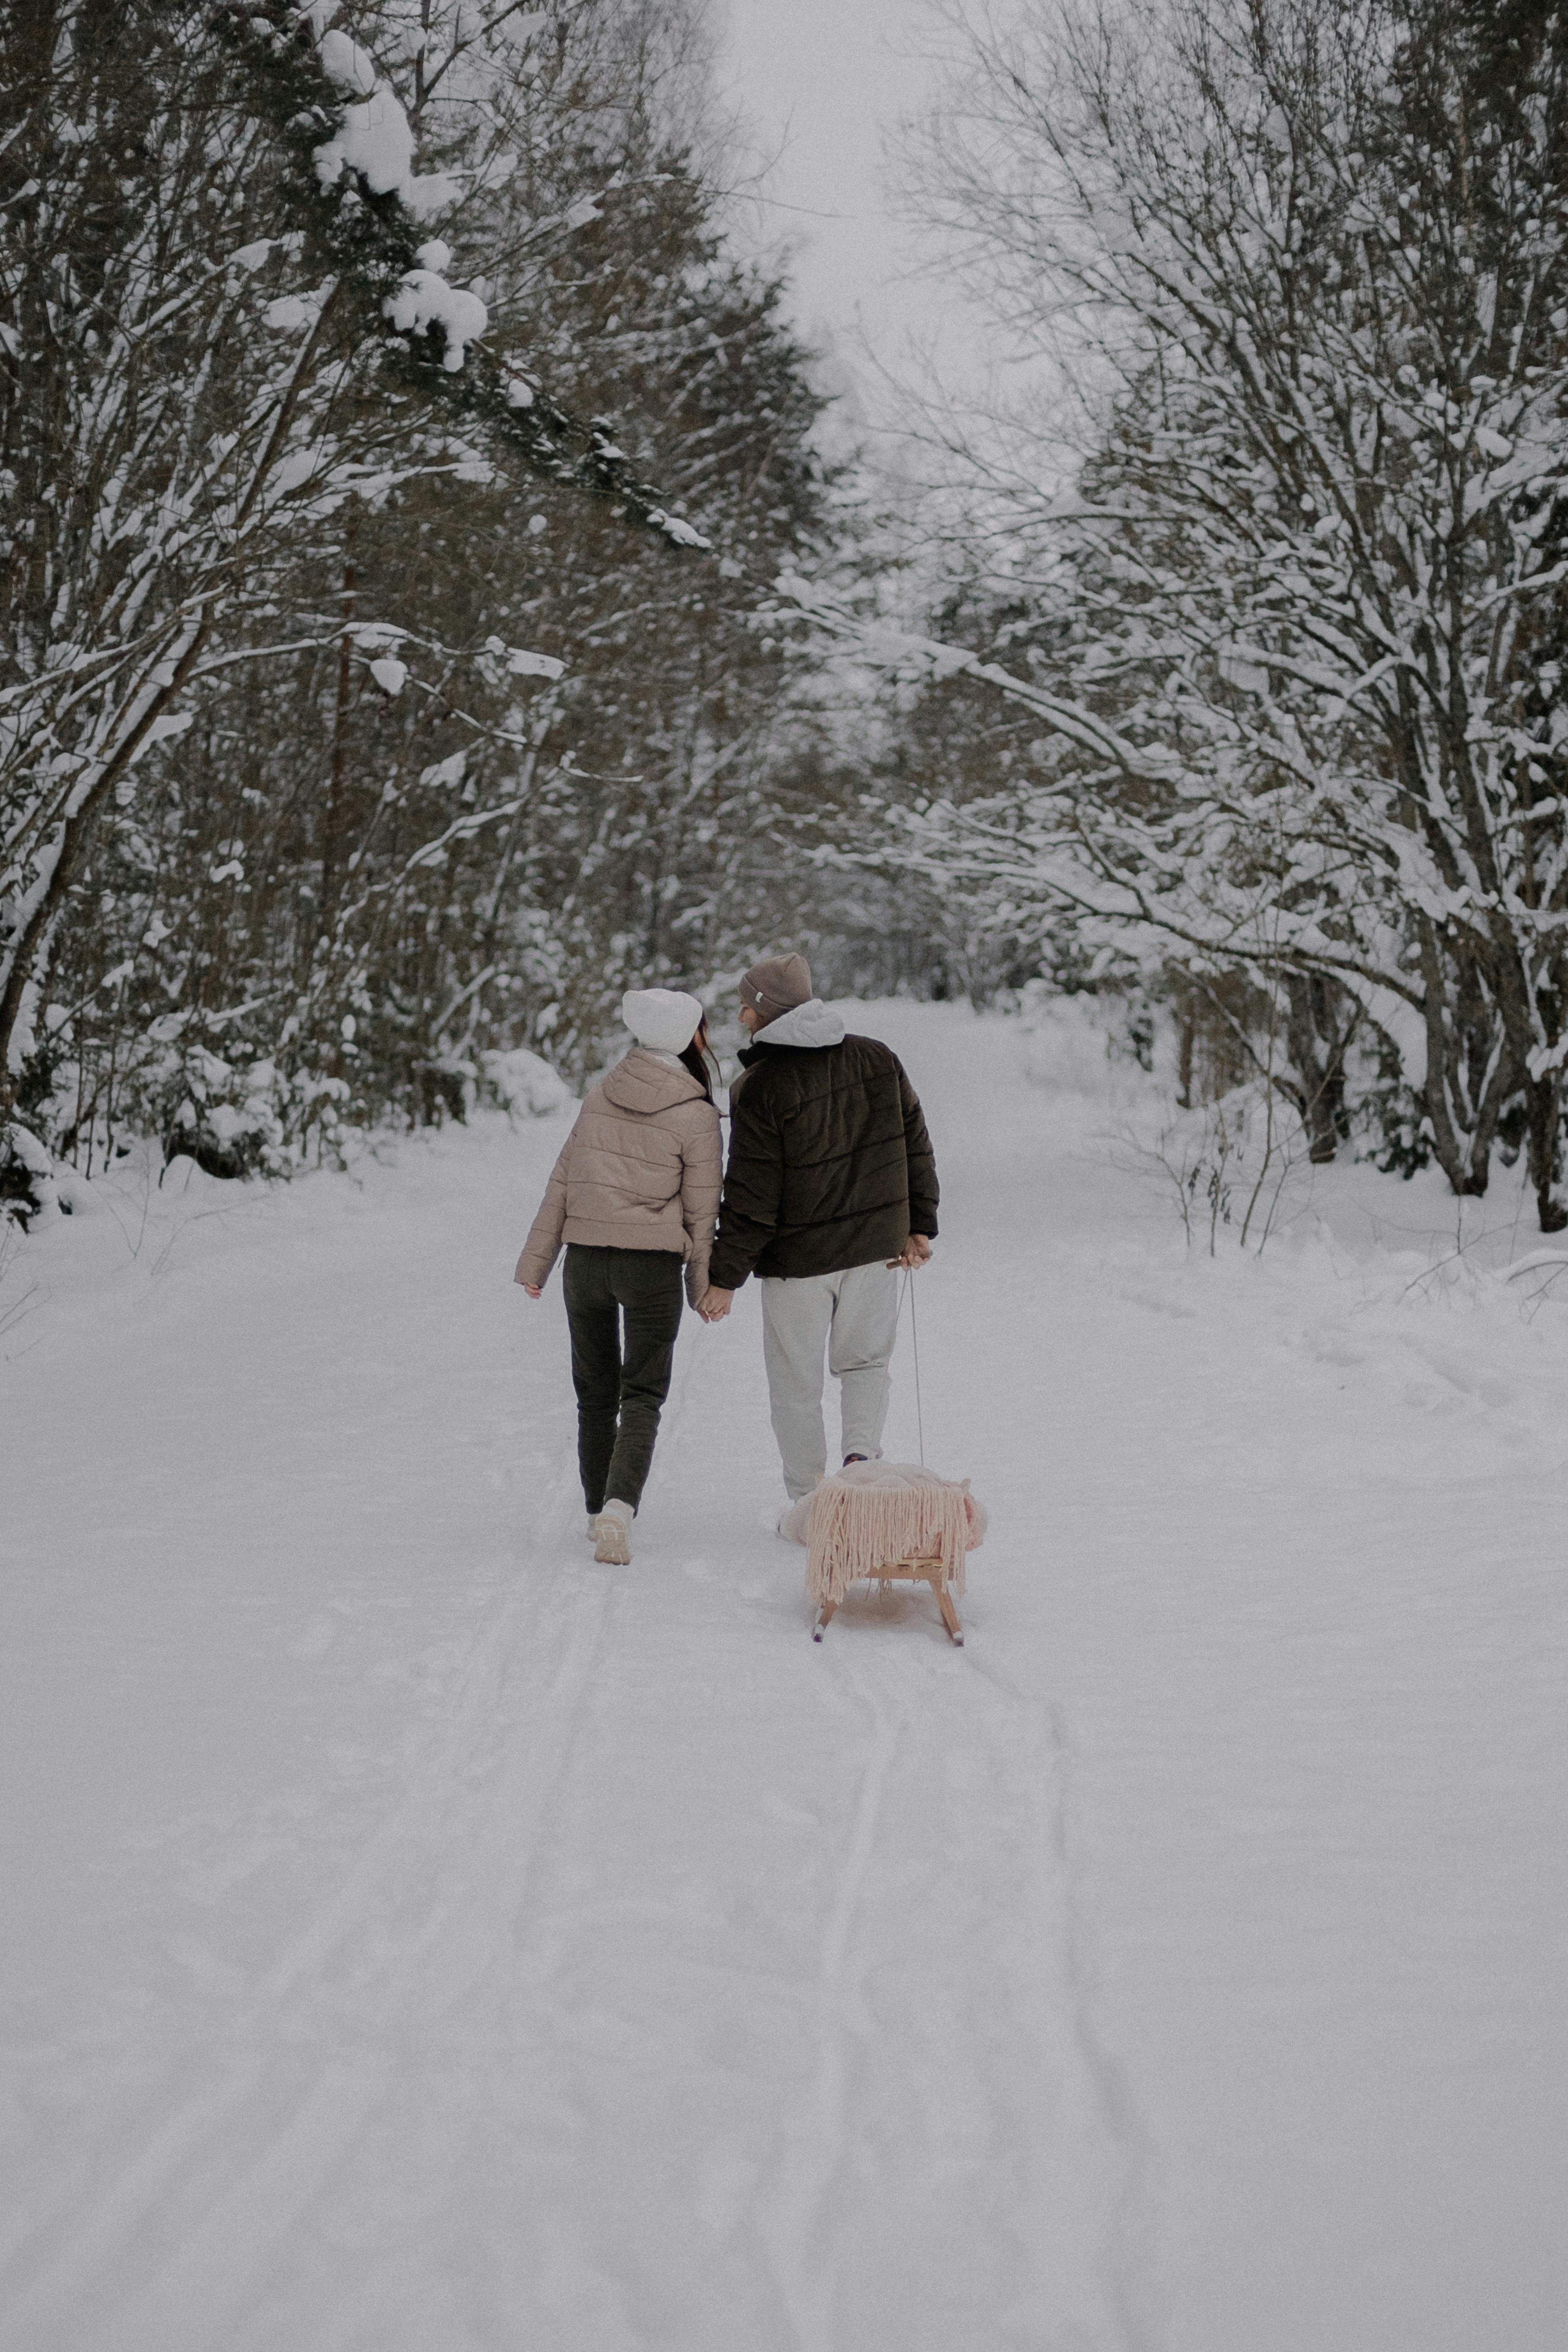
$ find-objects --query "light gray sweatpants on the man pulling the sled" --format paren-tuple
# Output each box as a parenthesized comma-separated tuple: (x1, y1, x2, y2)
(761, 1265, 898, 1503)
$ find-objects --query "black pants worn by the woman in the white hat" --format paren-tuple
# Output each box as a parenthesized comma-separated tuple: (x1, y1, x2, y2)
(564, 1242, 684, 1512)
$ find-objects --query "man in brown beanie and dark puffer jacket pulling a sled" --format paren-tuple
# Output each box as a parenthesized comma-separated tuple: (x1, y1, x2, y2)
(698, 955, 938, 1500)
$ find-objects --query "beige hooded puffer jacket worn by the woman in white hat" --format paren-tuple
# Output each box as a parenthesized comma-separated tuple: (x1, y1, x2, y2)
(515, 1047, 720, 1305)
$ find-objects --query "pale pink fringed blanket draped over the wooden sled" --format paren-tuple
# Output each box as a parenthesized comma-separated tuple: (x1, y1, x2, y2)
(780, 1463, 985, 1609)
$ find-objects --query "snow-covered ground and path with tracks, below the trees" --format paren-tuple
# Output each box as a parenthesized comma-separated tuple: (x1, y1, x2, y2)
(0, 1007, 1568, 2352)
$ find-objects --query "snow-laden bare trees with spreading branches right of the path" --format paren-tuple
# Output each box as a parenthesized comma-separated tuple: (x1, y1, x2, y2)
(827, 0, 1568, 1228)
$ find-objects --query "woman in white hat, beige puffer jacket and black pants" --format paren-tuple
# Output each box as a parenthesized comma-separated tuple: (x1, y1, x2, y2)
(517, 988, 720, 1564)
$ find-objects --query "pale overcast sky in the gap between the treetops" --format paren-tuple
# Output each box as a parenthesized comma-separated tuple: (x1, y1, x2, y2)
(715, 0, 945, 395)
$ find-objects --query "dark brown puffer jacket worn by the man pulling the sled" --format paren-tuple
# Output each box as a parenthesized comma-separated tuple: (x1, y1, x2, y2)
(708, 997, 938, 1291)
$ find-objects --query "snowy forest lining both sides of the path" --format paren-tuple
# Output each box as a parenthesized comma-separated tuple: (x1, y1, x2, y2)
(0, 0, 1568, 1230)
